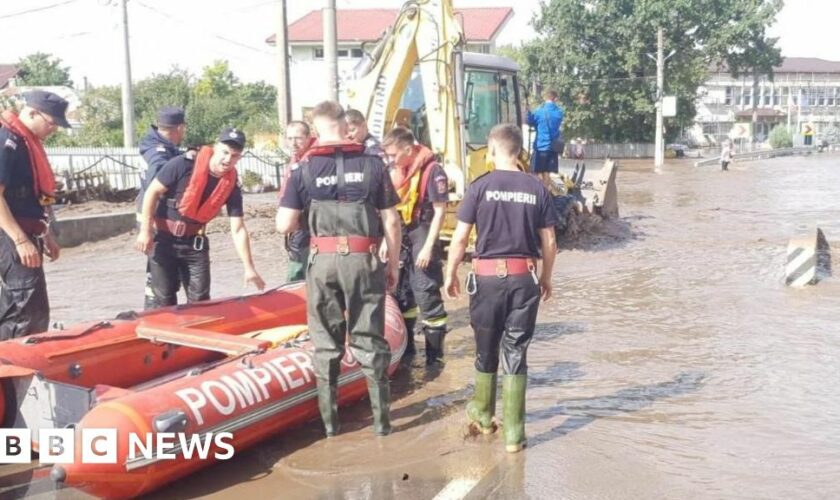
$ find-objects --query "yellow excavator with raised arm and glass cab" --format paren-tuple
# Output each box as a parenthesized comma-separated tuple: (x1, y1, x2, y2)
(344, 0, 618, 240)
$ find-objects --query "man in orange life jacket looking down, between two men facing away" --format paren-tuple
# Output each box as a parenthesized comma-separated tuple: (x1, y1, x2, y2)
(382, 127, 449, 365)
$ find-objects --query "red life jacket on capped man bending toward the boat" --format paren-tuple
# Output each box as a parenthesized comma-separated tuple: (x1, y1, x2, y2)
(178, 146, 236, 224)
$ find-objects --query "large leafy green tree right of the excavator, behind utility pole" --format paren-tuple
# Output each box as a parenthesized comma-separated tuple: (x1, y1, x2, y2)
(523, 0, 788, 142)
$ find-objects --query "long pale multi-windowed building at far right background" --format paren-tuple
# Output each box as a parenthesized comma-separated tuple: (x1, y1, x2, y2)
(691, 57, 840, 144)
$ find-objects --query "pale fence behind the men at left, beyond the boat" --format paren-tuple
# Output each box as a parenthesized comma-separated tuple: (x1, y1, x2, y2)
(46, 148, 286, 190)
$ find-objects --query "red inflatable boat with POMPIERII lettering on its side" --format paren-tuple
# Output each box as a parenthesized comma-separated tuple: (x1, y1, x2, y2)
(0, 284, 406, 498)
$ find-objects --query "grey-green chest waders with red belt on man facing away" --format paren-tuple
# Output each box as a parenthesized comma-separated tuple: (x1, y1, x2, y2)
(301, 151, 391, 437)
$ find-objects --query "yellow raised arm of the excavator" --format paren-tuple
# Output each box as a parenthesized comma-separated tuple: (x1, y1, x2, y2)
(345, 0, 468, 201)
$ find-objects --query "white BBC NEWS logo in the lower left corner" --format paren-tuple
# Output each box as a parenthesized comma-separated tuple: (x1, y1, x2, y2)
(0, 429, 234, 464)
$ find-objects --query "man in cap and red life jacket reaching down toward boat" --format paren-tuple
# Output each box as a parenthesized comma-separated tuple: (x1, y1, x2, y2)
(135, 128, 265, 307)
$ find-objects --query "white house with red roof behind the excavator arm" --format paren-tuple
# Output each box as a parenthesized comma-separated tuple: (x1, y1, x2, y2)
(266, 7, 513, 118)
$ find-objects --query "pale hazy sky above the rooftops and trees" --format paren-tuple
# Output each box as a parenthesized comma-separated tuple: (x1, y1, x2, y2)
(0, 0, 840, 86)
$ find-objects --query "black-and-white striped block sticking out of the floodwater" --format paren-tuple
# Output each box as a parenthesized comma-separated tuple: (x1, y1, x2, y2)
(785, 228, 831, 287)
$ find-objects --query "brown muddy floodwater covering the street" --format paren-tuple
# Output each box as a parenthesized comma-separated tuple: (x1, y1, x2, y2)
(0, 156, 840, 499)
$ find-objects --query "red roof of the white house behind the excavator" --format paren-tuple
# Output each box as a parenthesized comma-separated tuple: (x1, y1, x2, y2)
(266, 7, 513, 44)
